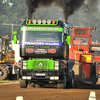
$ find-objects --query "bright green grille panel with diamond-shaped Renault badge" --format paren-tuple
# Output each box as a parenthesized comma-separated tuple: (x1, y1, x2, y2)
(27, 59, 54, 70)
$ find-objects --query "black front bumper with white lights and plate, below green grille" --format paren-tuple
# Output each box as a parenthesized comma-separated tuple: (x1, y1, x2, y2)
(21, 70, 62, 81)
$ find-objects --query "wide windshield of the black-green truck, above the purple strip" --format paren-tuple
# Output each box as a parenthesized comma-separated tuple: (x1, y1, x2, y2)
(21, 31, 62, 42)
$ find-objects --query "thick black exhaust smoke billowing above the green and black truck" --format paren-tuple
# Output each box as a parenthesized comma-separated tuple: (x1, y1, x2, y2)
(25, 0, 84, 20)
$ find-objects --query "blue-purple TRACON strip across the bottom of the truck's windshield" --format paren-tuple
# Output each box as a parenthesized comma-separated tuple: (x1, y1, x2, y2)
(20, 42, 62, 46)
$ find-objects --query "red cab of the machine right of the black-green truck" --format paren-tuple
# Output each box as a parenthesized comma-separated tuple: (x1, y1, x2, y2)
(69, 27, 92, 61)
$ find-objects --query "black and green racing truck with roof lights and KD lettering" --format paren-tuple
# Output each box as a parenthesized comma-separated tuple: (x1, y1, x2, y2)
(13, 19, 74, 88)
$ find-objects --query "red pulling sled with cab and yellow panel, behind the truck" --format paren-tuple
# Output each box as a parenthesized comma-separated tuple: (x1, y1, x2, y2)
(69, 27, 100, 84)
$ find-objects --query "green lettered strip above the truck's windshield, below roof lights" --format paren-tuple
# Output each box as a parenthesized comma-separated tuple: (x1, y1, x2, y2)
(21, 26, 64, 32)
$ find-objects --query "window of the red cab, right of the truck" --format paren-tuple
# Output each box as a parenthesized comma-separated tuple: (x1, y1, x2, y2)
(73, 37, 89, 45)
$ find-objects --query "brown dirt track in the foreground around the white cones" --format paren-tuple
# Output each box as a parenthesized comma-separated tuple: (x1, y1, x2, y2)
(0, 83, 100, 100)
